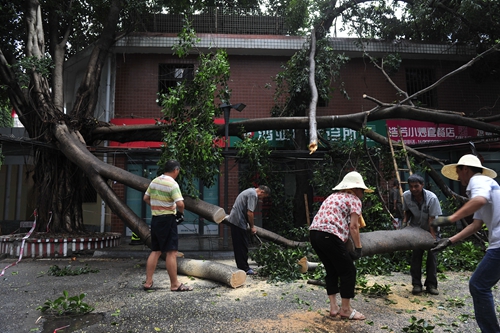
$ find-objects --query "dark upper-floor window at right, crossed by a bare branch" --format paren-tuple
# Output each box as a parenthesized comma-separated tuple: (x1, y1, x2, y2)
(406, 68, 437, 108)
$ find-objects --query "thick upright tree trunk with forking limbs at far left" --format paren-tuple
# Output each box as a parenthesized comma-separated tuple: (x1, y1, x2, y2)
(0, 0, 121, 233)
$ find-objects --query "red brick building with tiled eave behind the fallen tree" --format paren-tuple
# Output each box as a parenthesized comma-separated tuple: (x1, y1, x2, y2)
(2, 12, 500, 244)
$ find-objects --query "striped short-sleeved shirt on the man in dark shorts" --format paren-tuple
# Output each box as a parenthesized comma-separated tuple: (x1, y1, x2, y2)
(146, 175, 184, 216)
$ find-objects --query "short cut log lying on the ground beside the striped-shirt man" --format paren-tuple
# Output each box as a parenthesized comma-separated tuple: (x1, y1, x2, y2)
(177, 258, 247, 288)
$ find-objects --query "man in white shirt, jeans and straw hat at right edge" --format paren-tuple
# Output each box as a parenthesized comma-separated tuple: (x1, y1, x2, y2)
(432, 155, 500, 333)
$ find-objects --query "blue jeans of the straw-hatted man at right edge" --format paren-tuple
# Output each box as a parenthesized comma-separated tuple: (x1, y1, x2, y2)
(469, 248, 500, 333)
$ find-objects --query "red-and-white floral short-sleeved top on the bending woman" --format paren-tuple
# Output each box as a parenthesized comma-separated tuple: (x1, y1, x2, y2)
(309, 192, 362, 242)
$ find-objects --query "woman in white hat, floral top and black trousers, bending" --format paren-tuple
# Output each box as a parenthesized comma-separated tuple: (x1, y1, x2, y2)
(309, 171, 373, 320)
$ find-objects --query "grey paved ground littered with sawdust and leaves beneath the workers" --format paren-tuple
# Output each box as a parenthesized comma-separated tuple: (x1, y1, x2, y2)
(0, 241, 484, 333)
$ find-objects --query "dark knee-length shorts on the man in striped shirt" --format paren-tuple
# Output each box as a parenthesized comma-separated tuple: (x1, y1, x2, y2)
(151, 214, 179, 252)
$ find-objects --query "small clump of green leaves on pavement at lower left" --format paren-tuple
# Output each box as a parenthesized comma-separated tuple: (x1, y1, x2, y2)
(36, 290, 94, 316)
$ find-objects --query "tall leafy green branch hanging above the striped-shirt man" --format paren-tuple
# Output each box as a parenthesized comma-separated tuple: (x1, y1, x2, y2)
(158, 37, 229, 196)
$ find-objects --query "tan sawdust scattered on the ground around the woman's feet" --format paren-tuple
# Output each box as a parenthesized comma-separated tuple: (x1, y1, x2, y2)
(231, 272, 482, 333)
